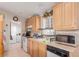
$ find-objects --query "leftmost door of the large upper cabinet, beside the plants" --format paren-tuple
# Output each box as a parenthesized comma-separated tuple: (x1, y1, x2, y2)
(53, 4, 62, 30)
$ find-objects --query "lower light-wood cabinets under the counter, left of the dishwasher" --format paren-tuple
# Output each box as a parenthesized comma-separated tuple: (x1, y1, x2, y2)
(27, 38, 47, 57)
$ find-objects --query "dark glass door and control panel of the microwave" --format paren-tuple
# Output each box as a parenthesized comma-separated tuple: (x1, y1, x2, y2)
(56, 35, 75, 44)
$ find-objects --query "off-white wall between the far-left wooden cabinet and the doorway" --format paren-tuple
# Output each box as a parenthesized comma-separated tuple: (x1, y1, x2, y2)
(0, 10, 24, 48)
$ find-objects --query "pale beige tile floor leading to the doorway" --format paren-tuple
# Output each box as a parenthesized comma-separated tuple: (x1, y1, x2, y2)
(4, 43, 30, 57)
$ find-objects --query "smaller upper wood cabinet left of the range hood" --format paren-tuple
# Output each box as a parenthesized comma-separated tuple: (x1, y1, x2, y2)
(25, 16, 40, 32)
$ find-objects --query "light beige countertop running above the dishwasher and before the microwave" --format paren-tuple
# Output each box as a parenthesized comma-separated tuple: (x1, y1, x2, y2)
(27, 38, 78, 52)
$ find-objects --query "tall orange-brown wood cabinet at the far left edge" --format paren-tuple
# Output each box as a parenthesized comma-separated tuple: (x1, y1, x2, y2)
(0, 15, 4, 56)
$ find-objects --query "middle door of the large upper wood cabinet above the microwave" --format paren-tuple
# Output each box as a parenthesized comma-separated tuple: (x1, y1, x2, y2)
(63, 3, 72, 27)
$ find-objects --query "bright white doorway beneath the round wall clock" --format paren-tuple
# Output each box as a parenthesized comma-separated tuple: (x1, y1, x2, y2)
(10, 21, 21, 44)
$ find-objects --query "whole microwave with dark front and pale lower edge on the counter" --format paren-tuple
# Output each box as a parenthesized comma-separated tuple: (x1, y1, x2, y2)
(56, 35, 76, 47)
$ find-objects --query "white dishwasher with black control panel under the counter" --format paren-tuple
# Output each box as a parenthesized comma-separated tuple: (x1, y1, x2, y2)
(47, 45, 69, 57)
